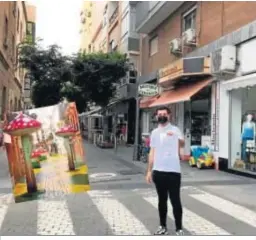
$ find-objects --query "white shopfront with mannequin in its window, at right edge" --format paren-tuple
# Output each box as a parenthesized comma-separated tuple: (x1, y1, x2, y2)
(220, 39, 256, 174)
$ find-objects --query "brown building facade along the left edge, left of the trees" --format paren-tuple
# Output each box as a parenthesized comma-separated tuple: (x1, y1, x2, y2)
(0, 1, 35, 116)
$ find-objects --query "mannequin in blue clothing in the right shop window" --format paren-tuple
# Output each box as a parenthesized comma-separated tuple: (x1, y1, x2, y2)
(242, 114, 256, 162)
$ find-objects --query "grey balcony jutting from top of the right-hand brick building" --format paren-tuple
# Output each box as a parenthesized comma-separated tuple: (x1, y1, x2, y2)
(136, 1, 184, 34)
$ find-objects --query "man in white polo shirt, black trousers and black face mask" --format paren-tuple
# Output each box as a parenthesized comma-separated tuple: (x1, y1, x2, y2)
(146, 107, 184, 235)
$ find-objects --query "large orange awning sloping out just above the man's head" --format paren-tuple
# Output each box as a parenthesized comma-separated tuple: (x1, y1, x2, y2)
(150, 78, 212, 107)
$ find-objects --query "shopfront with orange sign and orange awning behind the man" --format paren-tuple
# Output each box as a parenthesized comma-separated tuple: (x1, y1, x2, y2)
(149, 57, 212, 159)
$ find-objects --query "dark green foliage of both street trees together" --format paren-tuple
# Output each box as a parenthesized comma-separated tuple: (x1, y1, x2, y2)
(19, 41, 127, 112)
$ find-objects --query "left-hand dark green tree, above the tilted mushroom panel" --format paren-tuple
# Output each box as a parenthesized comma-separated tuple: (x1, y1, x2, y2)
(19, 41, 69, 107)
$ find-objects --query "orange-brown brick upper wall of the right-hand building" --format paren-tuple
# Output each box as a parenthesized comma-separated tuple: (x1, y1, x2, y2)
(137, 1, 256, 75)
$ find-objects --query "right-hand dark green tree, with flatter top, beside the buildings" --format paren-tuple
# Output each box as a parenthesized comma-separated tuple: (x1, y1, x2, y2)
(66, 52, 127, 107)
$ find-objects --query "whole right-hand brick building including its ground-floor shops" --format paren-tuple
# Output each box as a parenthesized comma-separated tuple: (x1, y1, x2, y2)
(136, 1, 256, 175)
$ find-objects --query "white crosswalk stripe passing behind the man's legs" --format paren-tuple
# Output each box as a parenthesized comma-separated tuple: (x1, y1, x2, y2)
(144, 197, 230, 235)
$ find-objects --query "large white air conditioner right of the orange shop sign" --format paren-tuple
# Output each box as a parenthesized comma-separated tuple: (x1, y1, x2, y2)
(211, 45, 237, 75)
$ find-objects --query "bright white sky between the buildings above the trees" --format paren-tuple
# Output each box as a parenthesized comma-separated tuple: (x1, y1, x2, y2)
(27, 0, 83, 54)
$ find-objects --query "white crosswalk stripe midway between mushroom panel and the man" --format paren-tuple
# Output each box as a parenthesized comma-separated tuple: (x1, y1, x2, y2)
(88, 191, 150, 235)
